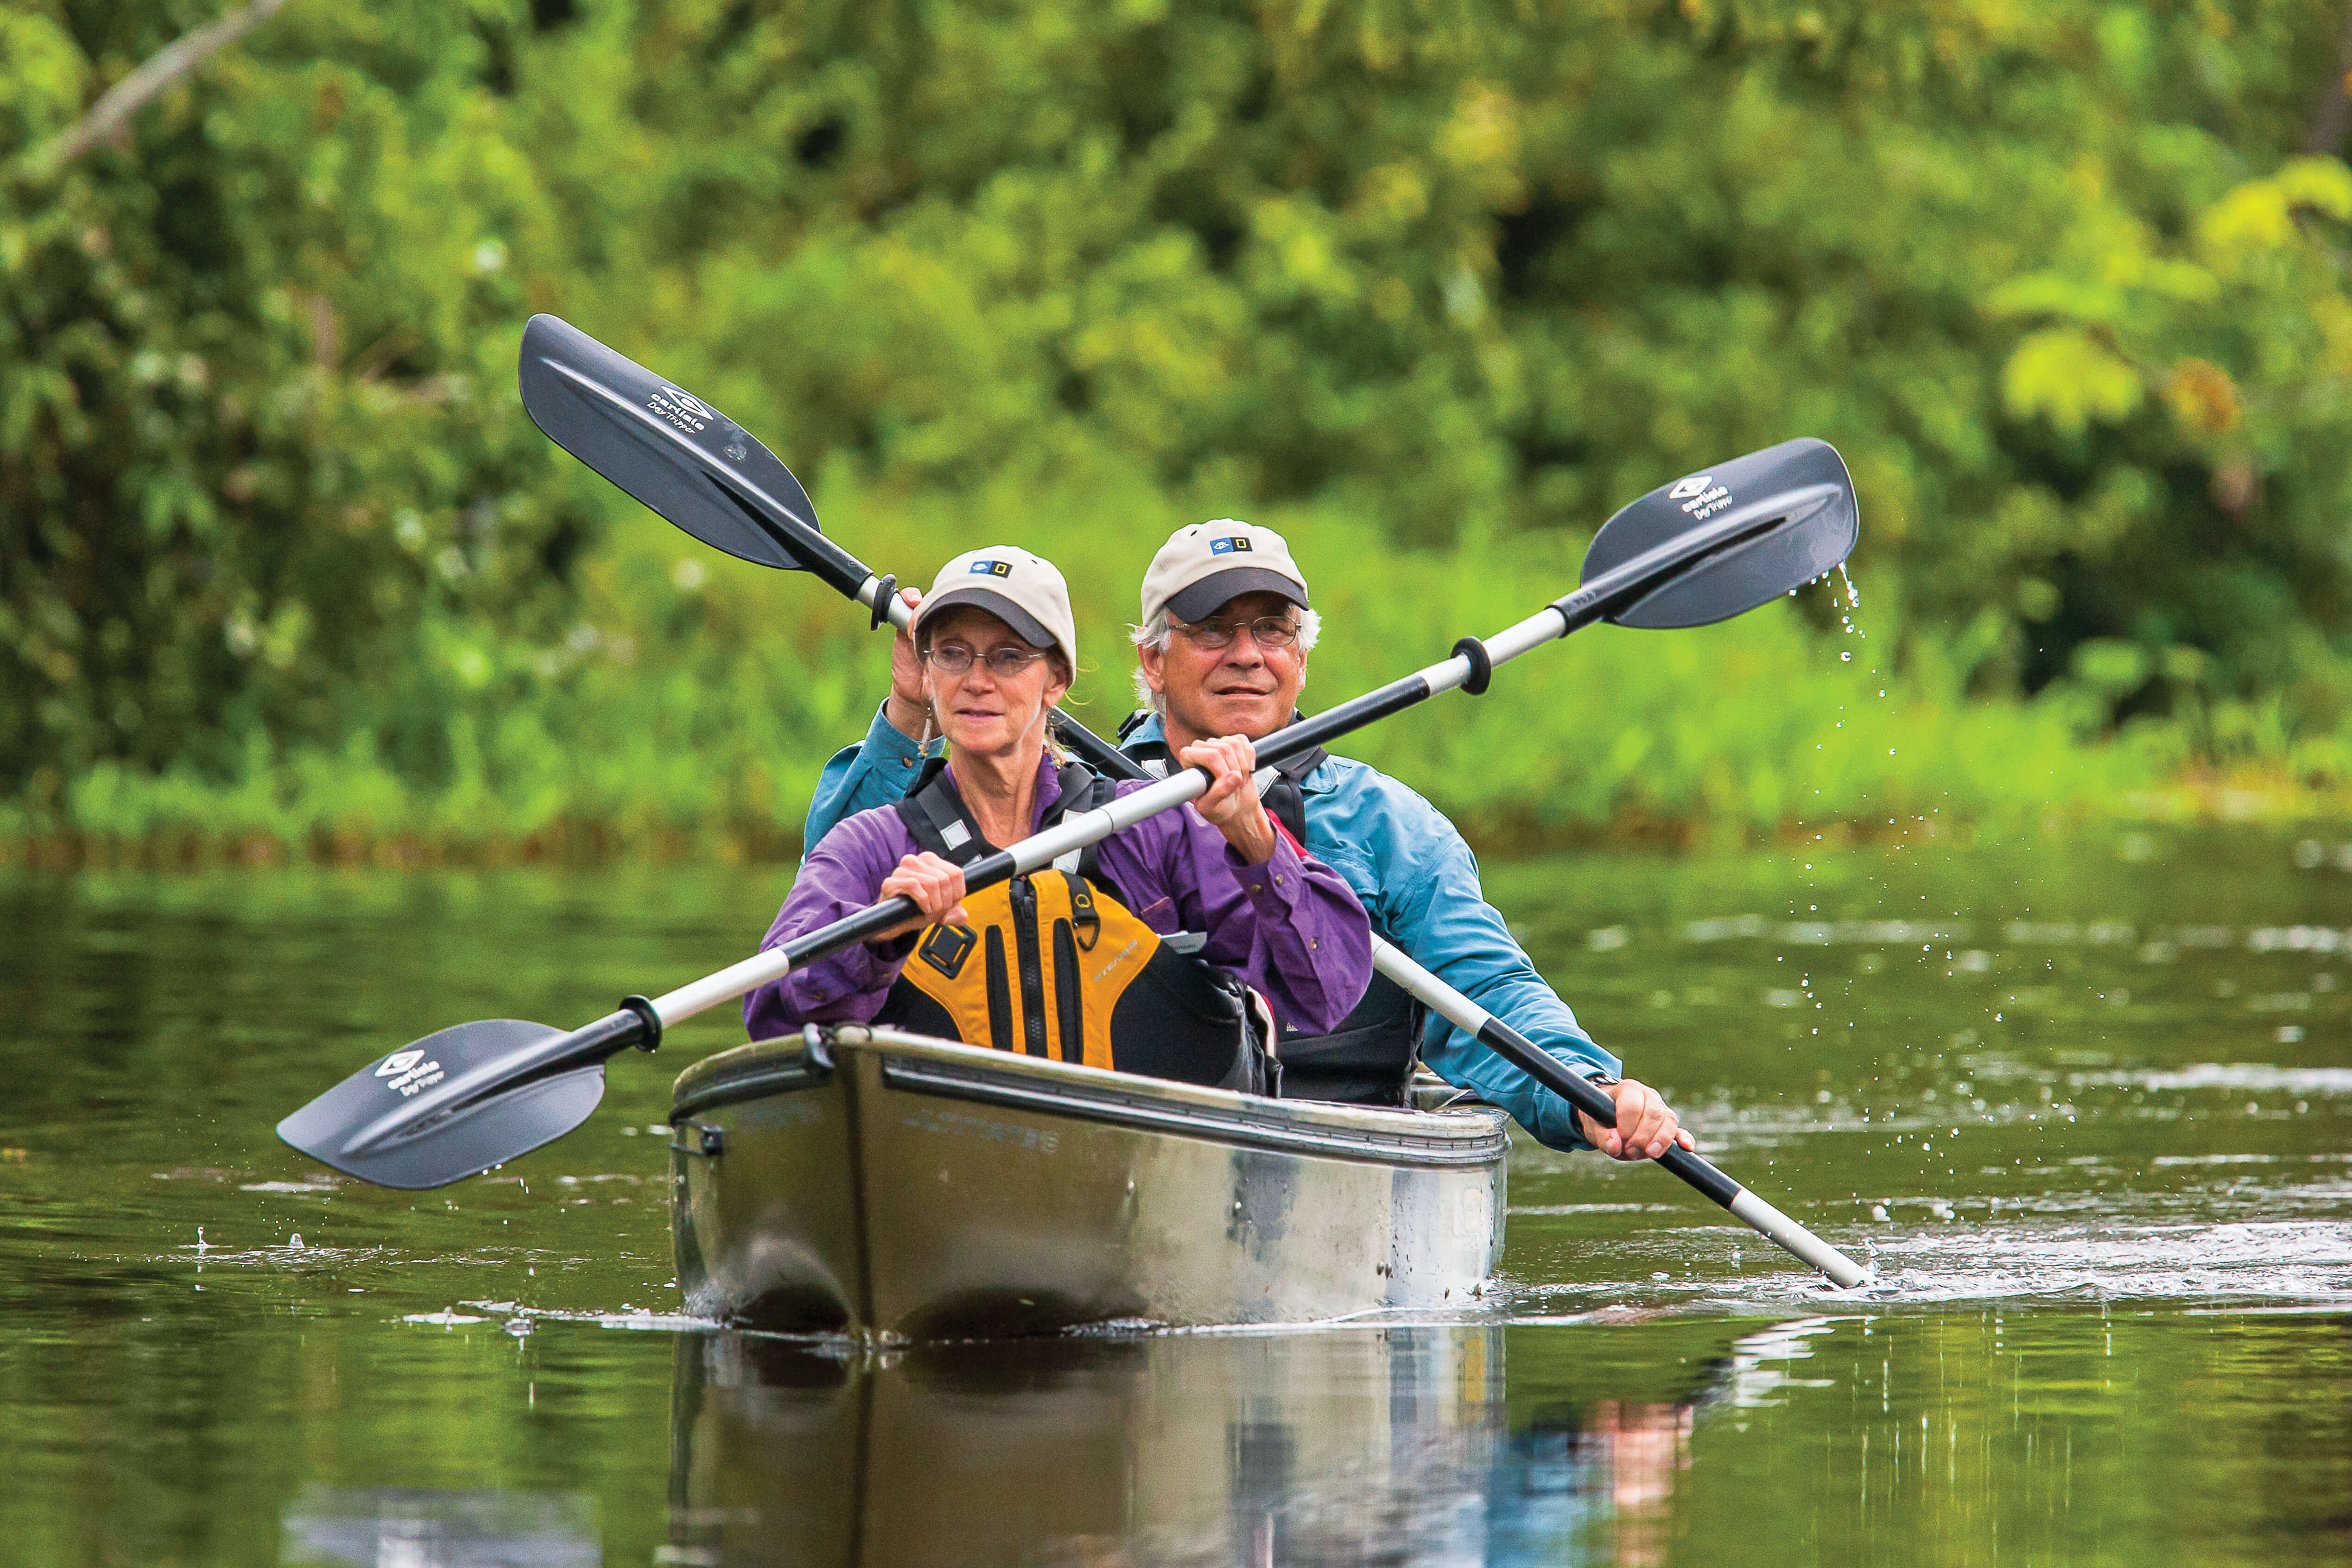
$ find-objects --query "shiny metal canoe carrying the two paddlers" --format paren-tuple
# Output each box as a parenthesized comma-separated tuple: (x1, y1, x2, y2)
(670, 1025, 1510, 1342)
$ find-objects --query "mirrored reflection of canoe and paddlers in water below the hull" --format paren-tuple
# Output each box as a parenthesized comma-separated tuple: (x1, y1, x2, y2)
(668, 1326, 1722, 1568)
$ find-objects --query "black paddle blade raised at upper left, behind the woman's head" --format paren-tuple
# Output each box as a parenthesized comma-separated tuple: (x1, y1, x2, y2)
(522, 315, 821, 571)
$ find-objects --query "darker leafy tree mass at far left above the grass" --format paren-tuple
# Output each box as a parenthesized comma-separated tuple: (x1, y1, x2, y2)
(0, 2, 586, 794)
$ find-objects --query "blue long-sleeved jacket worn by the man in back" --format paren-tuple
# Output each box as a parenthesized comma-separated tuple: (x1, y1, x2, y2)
(802, 708, 1618, 1149)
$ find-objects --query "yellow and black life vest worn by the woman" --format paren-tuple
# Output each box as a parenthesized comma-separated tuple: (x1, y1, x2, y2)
(875, 762, 1273, 1093)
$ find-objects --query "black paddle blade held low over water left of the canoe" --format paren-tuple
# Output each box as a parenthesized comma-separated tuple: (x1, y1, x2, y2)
(278, 1018, 604, 1189)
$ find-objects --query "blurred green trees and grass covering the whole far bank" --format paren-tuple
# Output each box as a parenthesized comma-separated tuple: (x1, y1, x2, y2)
(0, 0, 2352, 860)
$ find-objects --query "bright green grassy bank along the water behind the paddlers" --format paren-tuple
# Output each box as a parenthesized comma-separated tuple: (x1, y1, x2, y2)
(0, 475, 2333, 879)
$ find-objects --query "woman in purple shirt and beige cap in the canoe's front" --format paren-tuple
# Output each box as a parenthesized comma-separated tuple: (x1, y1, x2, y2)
(743, 546, 1371, 1088)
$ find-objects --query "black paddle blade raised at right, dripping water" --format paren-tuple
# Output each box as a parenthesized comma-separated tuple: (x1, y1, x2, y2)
(1583, 437, 1860, 630)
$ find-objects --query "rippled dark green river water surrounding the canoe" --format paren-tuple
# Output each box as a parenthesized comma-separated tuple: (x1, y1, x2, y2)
(0, 832, 2352, 1568)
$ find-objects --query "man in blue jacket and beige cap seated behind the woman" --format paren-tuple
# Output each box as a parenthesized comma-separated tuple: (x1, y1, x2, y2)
(807, 520, 1691, 1159)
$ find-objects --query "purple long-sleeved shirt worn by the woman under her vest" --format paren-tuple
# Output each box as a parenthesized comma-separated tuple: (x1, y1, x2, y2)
(743, 759, 1371, 1039)
